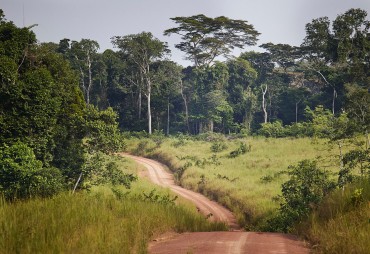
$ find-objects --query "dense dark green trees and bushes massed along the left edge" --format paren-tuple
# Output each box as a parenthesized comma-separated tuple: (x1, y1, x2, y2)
(0, 10, 134, 200)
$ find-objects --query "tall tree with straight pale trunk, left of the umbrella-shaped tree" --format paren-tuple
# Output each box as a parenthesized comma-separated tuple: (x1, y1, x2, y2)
(112, 32, 169, 134)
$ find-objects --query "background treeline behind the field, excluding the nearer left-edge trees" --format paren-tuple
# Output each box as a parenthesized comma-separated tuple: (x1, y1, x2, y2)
(29, 9, 370, 134)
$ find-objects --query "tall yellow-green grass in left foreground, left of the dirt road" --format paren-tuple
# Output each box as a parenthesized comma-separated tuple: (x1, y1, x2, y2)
(0, 156, 226, 253)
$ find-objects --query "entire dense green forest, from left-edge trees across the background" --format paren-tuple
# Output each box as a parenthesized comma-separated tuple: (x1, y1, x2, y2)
(0, 6, 370, 199)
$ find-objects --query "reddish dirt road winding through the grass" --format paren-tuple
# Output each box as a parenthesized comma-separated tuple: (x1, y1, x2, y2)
(122, 154, 309, 254)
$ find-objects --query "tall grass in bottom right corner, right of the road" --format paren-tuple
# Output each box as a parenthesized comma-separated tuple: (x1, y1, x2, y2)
(296, 179, 370, 254)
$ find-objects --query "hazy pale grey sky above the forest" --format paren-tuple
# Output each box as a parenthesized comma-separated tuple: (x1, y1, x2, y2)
(0, 0, 370, 65)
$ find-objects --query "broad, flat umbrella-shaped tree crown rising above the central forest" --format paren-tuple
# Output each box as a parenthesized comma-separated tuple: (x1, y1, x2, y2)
(164, 14, 259, 67)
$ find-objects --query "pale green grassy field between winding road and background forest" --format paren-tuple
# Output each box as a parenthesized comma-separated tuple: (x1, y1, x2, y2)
(128, 137, 339, 230)
